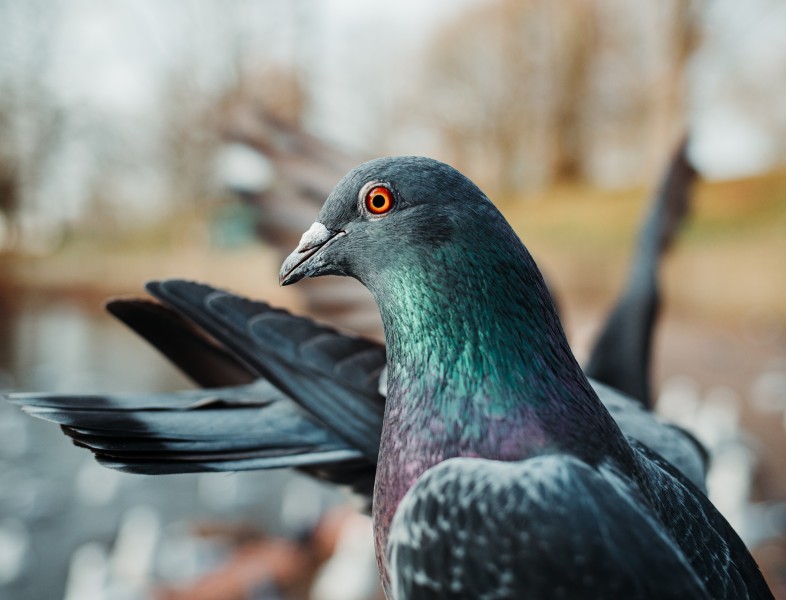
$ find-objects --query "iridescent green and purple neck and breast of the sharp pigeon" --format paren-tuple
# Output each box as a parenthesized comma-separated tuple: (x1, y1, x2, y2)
(352, 184, 629, 580)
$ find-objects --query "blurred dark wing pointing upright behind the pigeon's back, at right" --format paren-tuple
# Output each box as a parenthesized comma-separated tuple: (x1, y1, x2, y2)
(584, 140, 696, 410)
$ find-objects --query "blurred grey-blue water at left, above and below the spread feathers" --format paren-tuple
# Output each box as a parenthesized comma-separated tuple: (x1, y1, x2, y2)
(0, 298, 330, 600)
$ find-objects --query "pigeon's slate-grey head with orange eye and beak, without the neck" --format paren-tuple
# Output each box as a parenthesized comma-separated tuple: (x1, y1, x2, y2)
(280, 157, 496, 288)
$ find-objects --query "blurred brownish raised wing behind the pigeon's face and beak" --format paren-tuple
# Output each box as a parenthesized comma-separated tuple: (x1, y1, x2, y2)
(217, 96, 382, 337)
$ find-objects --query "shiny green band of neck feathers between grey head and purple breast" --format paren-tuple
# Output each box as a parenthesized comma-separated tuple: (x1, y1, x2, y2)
(367, 216, 591, 414)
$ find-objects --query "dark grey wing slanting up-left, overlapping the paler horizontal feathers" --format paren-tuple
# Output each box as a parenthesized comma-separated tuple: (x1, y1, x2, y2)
(147, 280, 385, 460)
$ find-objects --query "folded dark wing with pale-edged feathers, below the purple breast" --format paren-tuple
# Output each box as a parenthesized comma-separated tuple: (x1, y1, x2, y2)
(388, 455, 712, 600)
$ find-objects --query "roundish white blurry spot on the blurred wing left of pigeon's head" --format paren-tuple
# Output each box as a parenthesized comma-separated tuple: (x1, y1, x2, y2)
(216, 143, 276, 194)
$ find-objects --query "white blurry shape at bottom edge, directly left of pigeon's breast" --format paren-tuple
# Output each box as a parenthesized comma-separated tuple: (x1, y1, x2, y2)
(309, 513, 379, 600)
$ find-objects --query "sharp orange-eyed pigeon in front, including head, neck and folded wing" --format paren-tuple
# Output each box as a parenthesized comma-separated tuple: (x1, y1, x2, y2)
(280, 157, 772, 599)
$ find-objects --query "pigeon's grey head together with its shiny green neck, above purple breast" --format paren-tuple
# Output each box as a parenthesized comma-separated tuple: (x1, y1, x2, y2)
(280, 157, 578, 414)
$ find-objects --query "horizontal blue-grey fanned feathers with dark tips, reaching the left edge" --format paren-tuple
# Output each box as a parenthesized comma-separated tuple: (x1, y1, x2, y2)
(10, 380, 364, 475)
